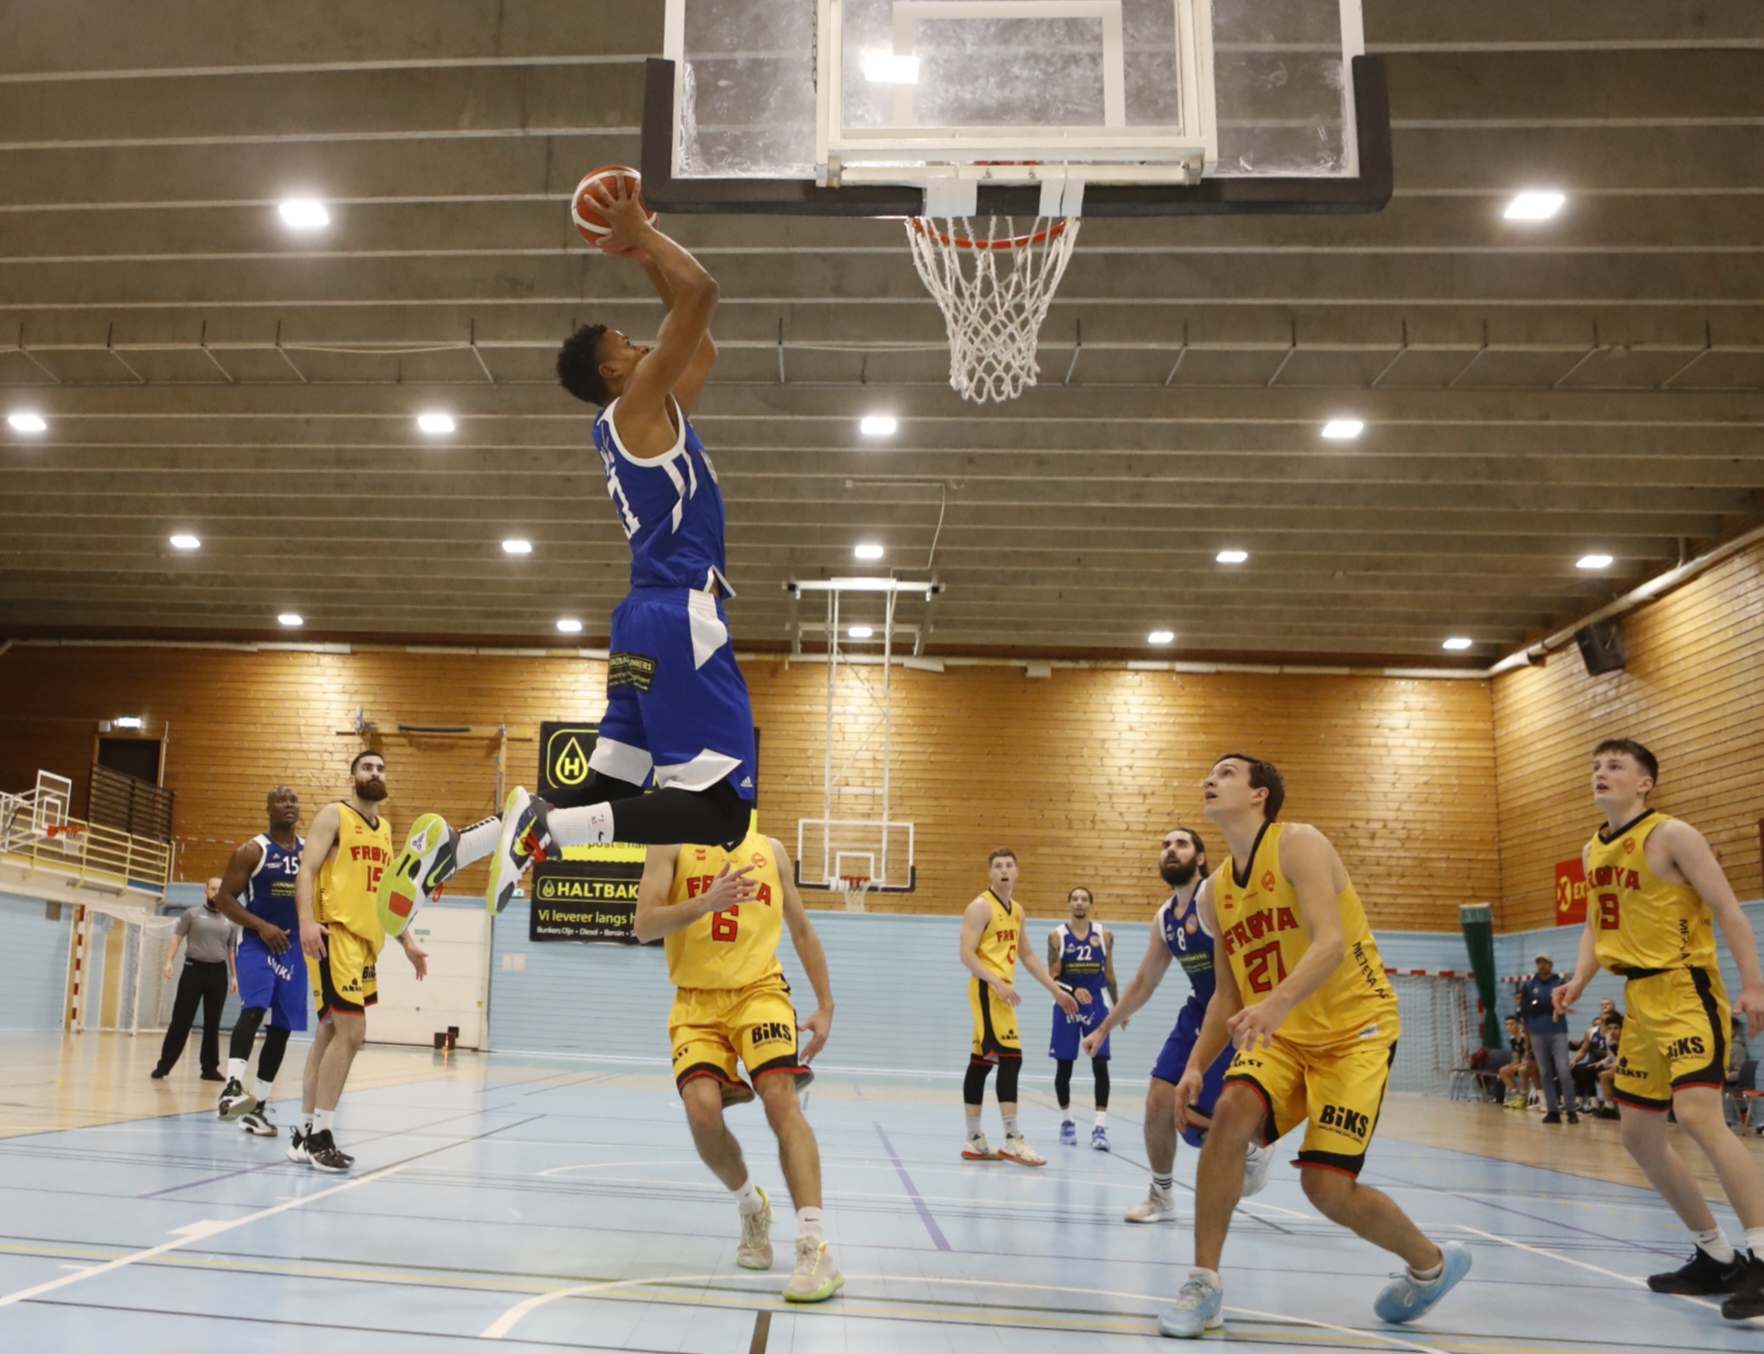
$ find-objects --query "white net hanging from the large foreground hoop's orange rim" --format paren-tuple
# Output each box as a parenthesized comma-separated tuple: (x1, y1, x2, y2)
(907, 217, 1078, 404)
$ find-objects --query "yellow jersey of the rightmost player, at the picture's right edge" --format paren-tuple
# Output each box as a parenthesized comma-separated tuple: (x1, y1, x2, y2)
(1586, 809, 1715, 973)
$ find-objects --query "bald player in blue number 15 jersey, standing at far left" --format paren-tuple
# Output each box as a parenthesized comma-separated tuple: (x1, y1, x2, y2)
(215, 785, 307, 1137)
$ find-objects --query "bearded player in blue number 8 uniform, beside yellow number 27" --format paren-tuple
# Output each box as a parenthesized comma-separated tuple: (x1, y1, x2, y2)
(1083, 827, 1274, 1222)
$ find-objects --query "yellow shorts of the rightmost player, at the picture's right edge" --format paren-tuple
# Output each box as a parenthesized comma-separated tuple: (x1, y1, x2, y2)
(1612, 968, 1732, 1111)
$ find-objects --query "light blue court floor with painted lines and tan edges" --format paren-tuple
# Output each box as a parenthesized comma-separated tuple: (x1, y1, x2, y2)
(0, 1035, 1764, 1354)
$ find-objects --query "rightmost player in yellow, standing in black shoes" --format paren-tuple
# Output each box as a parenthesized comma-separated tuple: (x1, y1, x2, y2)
(1551, 739, 1764, 1321)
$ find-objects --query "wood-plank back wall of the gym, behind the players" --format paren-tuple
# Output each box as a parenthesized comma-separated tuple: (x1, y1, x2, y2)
(0, 645, 1499, 929)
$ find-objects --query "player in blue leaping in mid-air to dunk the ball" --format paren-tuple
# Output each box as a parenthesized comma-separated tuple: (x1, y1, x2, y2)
(379, 178, 755, 934)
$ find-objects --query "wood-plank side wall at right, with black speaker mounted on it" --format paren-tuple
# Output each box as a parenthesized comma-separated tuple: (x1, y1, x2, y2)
(1494, 550, 1764, 931)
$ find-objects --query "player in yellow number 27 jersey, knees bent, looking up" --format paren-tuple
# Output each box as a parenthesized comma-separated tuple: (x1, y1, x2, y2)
(1157, 753, 1469, 1338)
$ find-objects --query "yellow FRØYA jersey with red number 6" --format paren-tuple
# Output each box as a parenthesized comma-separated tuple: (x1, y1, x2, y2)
(662, 830, 783, 989)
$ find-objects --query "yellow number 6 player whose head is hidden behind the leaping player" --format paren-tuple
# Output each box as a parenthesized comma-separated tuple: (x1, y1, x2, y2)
(633, 829, 845, 1303)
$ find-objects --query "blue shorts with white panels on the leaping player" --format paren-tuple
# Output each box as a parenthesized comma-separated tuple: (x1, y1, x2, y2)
(589, 587, 759, 799)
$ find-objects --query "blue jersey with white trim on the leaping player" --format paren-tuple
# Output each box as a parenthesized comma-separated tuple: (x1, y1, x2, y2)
(594, 400, 736, 598)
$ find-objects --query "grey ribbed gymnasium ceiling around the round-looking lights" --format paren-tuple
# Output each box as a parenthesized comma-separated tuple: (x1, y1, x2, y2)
(0, 0, 1764, 666)
